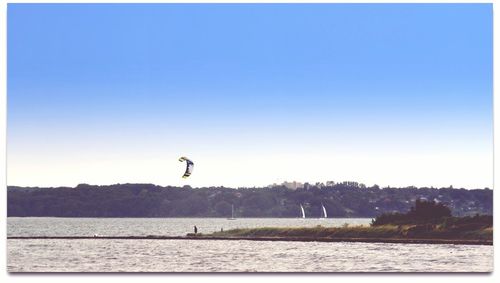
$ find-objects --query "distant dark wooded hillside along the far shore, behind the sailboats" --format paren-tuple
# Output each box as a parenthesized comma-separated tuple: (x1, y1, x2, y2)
(7, 184, 493, 218)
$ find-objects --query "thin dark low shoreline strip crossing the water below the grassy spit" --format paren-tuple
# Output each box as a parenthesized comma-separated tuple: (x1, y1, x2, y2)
(7, 235, 493, 246)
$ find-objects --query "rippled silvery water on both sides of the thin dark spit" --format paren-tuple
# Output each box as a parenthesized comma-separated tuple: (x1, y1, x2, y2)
(7, 218, 493, 272)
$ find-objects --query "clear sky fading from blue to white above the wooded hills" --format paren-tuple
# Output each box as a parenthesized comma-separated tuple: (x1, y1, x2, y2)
(7, 4, 493, 188)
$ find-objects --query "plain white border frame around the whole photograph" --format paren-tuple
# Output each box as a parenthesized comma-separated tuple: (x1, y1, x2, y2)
(0, 0, 500, 283)
